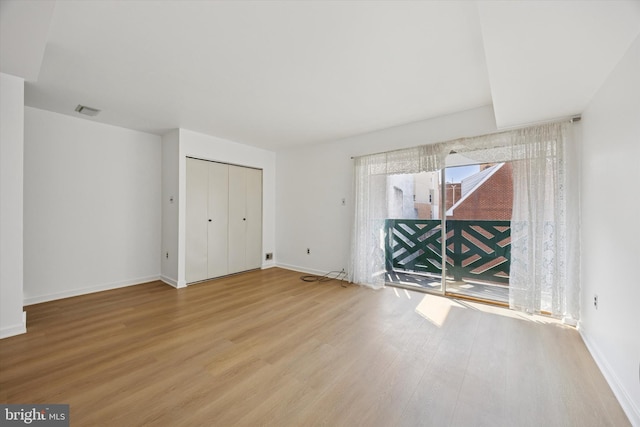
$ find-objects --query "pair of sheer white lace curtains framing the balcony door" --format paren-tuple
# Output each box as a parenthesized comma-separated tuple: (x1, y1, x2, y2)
(351, 122, 580, 324)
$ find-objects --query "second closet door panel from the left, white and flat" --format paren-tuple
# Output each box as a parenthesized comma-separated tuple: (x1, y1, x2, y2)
(206, 162, 229, 278)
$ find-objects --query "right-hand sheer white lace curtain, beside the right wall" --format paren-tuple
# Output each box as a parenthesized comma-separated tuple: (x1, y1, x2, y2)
(450, 122, 580, 324)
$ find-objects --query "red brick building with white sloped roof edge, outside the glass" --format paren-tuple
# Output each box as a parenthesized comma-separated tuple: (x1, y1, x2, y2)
(447, 163, 513, 221)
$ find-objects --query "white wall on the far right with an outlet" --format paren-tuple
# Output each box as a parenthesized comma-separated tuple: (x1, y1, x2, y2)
(580, 37, 640, 426)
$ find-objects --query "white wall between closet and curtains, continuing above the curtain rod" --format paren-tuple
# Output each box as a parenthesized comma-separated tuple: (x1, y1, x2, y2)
(275, 107, 496, 274)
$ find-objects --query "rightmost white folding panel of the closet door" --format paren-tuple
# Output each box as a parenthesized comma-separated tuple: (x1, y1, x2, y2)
(245, 169, 262, 270)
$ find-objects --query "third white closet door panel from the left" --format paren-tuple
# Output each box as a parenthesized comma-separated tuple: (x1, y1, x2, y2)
(228, 166, 247, 274)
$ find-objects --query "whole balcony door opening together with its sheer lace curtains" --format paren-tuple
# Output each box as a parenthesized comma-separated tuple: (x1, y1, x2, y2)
(350, 122, 580, 324)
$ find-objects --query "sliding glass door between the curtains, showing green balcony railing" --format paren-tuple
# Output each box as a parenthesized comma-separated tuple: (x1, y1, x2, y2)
(385, 162, 513, 304)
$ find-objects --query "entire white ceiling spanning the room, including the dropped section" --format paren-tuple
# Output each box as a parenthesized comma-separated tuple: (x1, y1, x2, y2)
(0, 0, 640, 149)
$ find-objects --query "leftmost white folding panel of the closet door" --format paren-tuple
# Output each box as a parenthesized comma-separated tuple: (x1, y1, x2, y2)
(185, 159, 209, 283)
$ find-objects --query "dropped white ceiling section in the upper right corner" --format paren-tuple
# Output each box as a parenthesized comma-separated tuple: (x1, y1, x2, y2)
(478, 0, 640, 127)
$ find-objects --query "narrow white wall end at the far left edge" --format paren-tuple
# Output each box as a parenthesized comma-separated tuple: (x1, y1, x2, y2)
(0, 73, 26, 338)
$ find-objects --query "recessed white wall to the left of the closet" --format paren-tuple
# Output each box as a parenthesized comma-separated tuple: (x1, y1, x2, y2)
(24, 107, 161, 304)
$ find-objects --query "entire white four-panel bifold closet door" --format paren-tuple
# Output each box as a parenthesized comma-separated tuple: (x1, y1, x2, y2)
(185, 157, 262, 283)
